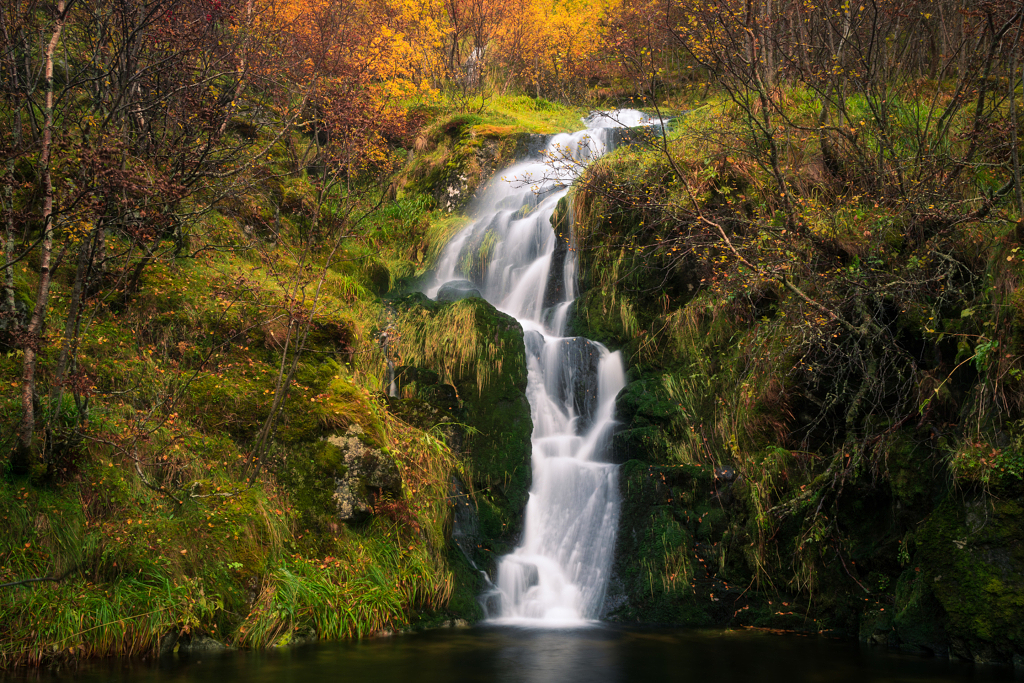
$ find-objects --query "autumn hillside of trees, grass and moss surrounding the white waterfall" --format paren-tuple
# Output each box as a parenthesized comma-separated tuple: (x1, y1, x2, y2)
(0, 0, 1024, 668)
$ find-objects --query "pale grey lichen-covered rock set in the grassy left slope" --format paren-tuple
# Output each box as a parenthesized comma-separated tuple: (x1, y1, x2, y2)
(327, 426, 401, 522)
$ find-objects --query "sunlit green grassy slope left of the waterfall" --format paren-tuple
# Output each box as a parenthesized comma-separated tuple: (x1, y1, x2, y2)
(0, 93, 580, 667)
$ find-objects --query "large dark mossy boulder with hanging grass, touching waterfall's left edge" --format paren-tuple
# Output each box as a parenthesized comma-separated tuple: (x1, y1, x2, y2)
(389, 294, 534, 569)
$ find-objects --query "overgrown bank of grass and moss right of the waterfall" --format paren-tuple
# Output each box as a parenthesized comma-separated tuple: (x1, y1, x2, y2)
(573, 66, 1024, 661)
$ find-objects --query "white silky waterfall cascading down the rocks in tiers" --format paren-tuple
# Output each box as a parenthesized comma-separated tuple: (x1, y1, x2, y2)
(426, 110, 652, 626)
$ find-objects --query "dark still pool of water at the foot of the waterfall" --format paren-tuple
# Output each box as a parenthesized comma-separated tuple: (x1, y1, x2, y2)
(0, 627, 1024, 683)
